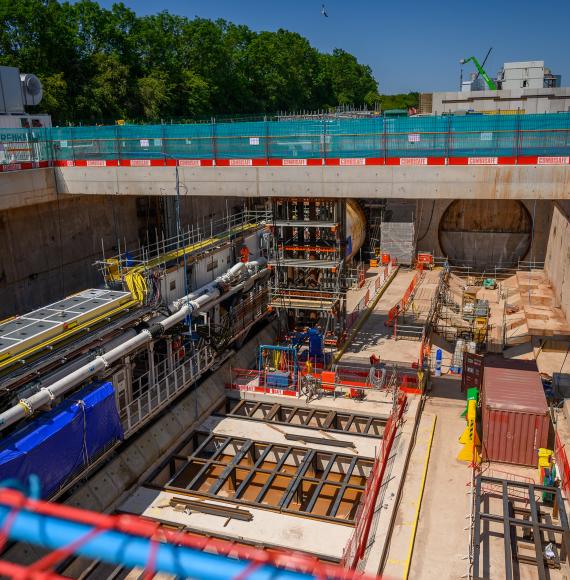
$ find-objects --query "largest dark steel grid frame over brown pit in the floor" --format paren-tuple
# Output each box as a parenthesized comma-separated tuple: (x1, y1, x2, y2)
(144, 431, 374, 525)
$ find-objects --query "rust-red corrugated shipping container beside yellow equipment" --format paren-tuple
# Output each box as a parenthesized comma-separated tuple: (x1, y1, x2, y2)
(482, 357, 550, 467)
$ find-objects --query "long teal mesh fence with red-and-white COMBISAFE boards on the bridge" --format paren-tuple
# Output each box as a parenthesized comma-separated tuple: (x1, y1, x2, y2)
(0, 113, 570, 169)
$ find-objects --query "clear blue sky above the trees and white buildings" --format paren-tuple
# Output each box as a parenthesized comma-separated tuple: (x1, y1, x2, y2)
(93, 0, 570, 94)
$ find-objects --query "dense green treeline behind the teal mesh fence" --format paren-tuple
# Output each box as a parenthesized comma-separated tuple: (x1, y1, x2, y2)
(0, 0, 379, 124)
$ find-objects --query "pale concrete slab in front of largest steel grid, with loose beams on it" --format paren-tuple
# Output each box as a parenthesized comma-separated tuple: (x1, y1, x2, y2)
(120, 487, 352, 560)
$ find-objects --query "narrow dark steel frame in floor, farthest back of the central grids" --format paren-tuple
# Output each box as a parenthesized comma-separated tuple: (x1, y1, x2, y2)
(218, 399, 388, 439)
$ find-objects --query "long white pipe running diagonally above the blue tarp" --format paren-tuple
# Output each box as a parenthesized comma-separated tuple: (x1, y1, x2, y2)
(0, 259, 265, 431)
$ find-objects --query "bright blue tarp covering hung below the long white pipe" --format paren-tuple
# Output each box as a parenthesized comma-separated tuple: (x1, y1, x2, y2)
(0, 382, 123, 498)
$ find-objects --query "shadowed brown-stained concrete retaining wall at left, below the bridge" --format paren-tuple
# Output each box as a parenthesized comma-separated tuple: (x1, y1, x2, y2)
(0, 193, 242, 319)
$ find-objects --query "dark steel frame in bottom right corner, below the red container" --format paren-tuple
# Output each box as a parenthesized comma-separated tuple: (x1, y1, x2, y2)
(473, 475, 570, 580)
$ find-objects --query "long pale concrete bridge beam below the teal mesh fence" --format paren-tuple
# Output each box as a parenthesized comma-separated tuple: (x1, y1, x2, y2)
(0, 164, 570, 210)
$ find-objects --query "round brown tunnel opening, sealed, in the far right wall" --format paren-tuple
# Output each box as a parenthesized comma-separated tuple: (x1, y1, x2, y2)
(438, 199, 532, 269)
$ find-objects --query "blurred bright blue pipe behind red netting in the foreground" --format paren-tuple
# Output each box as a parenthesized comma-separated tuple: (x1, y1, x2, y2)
(0, 505, 313, 580)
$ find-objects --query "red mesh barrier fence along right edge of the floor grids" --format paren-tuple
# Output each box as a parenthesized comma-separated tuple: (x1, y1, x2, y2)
(341, 393, 407, 570)
